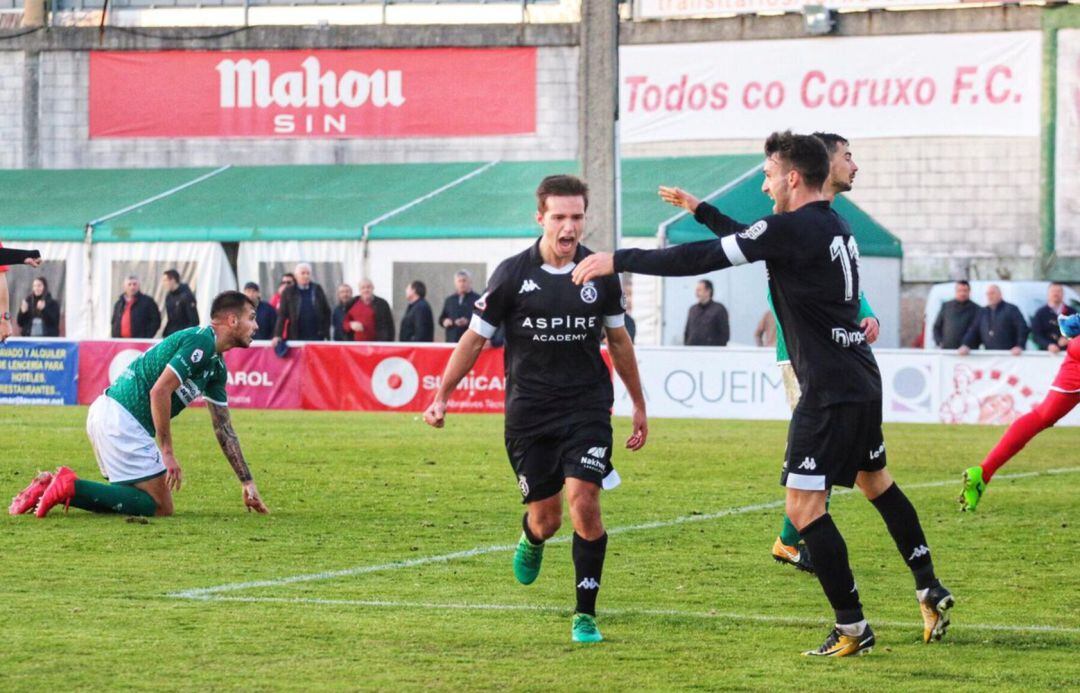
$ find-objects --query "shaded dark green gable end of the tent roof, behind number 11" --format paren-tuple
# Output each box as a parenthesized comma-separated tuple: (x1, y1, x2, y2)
(665, 166, 903, 258)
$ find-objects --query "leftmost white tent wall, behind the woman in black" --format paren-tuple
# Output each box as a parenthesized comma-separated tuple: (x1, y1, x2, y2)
(4, 241, 90, 339)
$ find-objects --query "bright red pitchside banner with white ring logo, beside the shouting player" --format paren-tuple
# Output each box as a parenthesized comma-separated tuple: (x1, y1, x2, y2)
(302, 344, 507, 413)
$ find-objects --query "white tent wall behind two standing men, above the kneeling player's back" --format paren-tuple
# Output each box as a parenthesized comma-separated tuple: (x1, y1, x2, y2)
(86, 243, 237, 338)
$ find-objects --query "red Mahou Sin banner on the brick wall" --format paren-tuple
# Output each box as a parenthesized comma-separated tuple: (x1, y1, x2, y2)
(90, 47, 537, 138)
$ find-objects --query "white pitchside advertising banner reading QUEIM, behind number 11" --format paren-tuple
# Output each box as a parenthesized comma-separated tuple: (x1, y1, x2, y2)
(615, 347, 1080, 426)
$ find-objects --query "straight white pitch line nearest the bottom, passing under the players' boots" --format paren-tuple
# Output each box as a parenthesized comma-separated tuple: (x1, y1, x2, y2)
(181, 596, 1080, 635)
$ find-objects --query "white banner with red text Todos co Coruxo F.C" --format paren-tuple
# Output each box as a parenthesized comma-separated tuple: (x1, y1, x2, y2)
(619, 31, 1042, 142)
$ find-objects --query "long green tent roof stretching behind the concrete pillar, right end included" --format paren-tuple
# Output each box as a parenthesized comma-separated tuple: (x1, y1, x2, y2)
(0, 154, 900, 252)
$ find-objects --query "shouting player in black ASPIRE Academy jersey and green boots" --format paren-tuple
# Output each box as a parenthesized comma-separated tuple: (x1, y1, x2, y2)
(423, 176, 648, 642)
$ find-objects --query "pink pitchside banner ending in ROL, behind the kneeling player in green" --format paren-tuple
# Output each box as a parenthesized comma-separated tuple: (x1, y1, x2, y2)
(71, 339, 305, 409)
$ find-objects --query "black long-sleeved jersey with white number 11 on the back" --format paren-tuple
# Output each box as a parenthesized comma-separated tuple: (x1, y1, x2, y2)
(615, 201, 881, 406)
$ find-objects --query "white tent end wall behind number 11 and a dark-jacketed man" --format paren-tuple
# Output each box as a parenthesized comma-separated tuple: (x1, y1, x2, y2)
(661, 257, 900, 349)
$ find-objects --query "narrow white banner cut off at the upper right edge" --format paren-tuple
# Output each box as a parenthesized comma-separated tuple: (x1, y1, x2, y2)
(1054, 29, 1080, 256)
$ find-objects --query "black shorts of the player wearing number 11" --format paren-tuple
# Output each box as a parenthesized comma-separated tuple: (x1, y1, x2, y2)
(780, 400, 885, 491)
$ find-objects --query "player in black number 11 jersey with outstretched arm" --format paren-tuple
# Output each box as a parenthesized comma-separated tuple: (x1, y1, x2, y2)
(573, 132, 953, 656)
